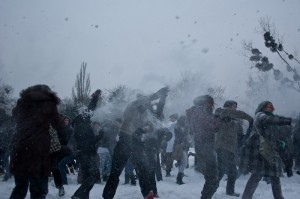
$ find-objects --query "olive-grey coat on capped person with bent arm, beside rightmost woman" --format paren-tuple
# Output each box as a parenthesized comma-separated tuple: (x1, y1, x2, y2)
(215, 108, 253, 154)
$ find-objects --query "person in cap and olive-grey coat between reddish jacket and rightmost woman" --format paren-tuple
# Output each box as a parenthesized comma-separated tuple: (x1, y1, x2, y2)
(215, 100, 253, 197)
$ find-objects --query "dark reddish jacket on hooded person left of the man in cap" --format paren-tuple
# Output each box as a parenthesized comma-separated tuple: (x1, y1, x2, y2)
(186, 105, 220, 146)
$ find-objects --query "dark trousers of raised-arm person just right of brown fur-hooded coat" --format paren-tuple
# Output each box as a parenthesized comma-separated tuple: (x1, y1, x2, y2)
(74, 153, 100, 199)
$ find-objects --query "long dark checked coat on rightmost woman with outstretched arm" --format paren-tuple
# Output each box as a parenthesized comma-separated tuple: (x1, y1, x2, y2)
(240, 112, 291, 177)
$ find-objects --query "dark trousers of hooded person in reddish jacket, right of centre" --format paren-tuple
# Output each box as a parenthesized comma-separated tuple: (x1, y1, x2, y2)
(195, 142, 219, 199)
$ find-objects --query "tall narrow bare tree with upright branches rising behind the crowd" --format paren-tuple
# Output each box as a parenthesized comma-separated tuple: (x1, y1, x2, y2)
(72, 62, 91, 105)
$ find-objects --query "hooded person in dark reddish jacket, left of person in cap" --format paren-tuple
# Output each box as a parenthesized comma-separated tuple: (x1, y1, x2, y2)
(186, 95, 219, 199)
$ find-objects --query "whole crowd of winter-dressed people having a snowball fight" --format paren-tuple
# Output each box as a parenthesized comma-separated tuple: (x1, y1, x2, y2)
(0, 85, 300, 199)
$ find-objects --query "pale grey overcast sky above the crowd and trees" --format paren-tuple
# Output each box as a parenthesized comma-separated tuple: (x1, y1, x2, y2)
(0, 0, 300, 97)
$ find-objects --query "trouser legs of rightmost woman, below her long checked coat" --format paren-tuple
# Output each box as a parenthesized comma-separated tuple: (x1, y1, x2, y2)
(242, 173, 284, 199)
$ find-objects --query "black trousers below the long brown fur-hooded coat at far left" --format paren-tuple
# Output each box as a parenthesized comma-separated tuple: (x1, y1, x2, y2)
(10, 175, 48, 199)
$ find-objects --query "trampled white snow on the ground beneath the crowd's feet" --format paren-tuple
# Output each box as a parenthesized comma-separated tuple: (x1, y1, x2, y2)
(0, 157, 300, 199)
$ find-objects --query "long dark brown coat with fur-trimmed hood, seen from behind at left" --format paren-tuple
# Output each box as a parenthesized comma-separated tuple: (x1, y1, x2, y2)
(10, 85, 64, 178)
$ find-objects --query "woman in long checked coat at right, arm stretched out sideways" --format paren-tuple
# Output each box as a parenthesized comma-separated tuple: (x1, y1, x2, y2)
(242, 101, 292, 199)
